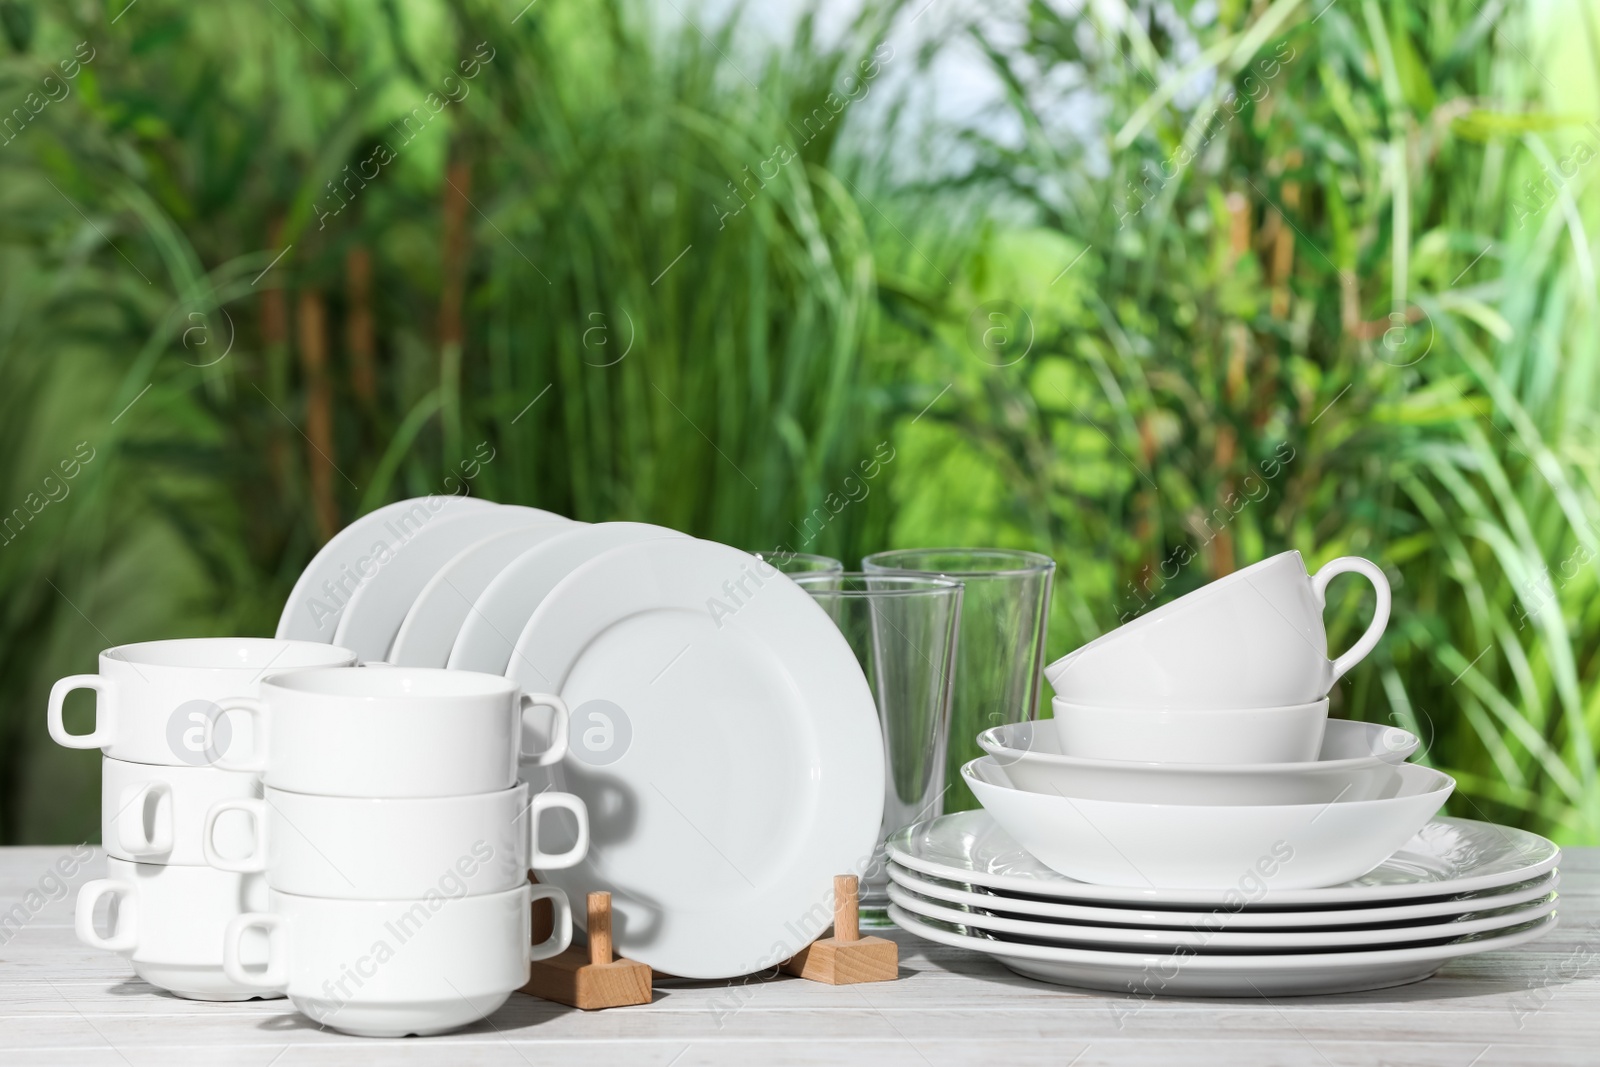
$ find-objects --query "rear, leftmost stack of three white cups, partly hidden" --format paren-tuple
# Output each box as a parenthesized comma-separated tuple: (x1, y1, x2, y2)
(50, 638, 355, 1000)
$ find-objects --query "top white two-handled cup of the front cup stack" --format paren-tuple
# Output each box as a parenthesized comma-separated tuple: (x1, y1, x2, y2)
(218, 667, 568, 797)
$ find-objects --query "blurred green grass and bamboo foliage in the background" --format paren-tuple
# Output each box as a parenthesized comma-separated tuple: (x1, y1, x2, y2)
(0, 0, 1600, 841)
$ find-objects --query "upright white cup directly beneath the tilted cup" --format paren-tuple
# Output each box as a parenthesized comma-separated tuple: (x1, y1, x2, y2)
(1050, 697, 1328, 763)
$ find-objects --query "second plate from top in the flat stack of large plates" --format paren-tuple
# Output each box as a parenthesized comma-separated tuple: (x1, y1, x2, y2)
(888, 864, 1562, 929)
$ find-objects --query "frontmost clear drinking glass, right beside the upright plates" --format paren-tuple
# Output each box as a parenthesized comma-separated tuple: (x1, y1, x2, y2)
(795, 573, 962, 926)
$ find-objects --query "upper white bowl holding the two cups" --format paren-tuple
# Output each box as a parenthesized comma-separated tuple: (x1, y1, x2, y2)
(978, 718, 1419, 805)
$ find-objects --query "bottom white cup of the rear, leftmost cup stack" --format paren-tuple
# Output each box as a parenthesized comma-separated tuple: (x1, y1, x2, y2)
(74, 856, 282, 1000)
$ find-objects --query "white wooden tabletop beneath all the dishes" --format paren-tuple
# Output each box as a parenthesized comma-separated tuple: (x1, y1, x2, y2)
(0, 848, 1600, 1067)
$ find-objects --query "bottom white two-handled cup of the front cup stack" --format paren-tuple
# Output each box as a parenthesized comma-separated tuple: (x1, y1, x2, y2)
(222, 883, 573, 1037)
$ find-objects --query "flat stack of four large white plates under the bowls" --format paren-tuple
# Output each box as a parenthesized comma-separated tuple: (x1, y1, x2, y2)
(888, 811, 1560, 997)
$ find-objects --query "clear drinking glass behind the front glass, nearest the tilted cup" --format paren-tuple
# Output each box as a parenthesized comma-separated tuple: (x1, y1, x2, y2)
(861, 549, 1056, 811)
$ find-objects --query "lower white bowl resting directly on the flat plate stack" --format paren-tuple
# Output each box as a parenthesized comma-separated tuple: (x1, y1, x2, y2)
(962, 757, 1456, 901)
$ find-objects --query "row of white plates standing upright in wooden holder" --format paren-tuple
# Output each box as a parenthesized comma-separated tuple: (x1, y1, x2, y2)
(278, 496, 883, 979)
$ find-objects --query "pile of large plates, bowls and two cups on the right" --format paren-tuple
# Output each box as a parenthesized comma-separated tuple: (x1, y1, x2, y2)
(888, 552, 1560, 997)
